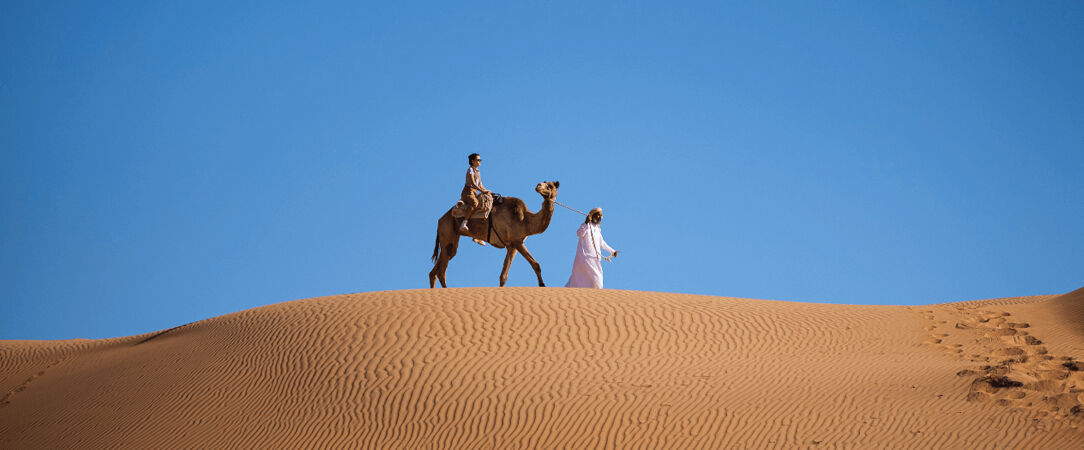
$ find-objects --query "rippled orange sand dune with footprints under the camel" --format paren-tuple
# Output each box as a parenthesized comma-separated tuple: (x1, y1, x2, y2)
(0, 287, 1084, 449)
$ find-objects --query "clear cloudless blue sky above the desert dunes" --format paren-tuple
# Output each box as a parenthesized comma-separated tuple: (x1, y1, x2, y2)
(0, 1, 1084, 339)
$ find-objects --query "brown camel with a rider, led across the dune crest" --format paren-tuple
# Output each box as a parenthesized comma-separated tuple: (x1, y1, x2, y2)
(429, 181, 560, 288)
